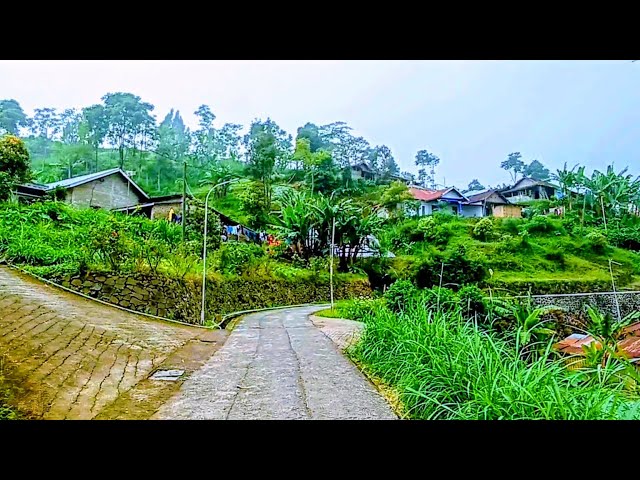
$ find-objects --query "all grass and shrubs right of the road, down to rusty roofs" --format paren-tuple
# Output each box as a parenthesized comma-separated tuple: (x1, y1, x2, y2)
(330, 280, 640, 420)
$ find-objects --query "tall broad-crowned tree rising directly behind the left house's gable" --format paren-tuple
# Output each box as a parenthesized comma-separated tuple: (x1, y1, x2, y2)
(102, 92, 155, 168)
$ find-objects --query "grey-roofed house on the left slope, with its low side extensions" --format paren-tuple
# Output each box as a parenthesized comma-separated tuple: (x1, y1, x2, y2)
(15, 168, 182, 219)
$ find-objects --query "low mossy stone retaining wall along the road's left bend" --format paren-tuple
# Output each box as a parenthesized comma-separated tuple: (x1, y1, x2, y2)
(58, 273, 371, 324)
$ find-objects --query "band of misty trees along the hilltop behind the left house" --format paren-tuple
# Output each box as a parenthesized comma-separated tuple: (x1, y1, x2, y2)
(0, 92, 410, 194)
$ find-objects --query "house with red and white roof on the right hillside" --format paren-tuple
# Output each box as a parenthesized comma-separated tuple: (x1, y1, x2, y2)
(409, 186, 484, 217)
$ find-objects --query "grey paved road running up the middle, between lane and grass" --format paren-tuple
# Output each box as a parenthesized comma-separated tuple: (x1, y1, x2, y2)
(152, 307, 396, 419)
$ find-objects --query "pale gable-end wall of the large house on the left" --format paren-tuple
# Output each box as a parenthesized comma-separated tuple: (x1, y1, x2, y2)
(66, 173, 142, 210)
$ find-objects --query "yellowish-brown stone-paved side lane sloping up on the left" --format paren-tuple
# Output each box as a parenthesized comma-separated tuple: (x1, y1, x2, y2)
(0, 266, 224, 419)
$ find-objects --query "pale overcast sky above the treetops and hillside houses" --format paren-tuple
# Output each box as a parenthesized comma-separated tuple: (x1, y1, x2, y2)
(0, 60, 640, 187)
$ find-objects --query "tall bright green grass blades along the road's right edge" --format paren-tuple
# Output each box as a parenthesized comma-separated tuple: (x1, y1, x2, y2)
(349, 307, 640, 420)
